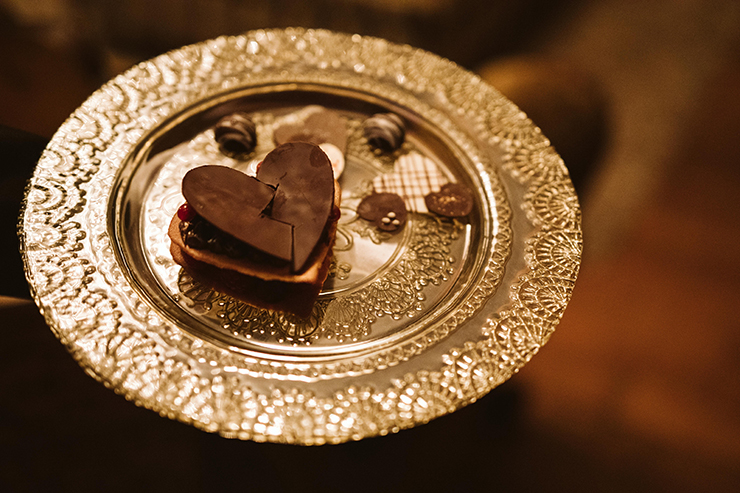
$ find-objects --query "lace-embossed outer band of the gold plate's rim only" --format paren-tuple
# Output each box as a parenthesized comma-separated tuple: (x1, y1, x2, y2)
(19, 29, 582, 445)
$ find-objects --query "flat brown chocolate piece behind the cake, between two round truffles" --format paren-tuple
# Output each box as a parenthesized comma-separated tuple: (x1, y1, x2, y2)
(272, 105, 347, 154)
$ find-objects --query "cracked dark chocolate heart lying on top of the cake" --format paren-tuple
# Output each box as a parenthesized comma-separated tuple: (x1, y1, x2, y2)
(182, 142, 334, 272)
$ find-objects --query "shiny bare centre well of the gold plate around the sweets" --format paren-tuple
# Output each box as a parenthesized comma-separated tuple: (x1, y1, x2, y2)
(115, 89, 481, 356)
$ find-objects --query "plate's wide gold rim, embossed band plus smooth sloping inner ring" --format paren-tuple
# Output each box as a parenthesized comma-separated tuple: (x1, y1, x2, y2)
(19, 28, 582, 445)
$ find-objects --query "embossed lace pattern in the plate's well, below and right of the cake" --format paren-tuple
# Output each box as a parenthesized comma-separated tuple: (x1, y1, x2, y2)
(177, 213, 460, 344)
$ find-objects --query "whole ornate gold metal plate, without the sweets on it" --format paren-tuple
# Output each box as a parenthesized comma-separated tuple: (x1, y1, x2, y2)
(20, 29, 581, 444)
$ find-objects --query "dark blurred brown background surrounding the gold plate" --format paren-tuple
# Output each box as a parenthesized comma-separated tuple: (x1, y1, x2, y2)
(0, 0, 740, 492)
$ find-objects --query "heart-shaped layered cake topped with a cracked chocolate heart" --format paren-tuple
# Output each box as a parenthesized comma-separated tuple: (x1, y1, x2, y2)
(168, 142, 340, 317)
